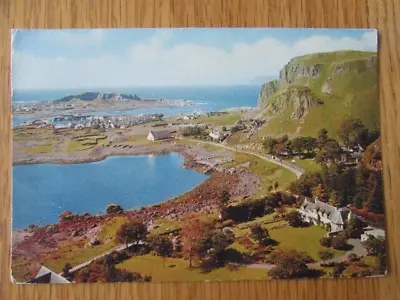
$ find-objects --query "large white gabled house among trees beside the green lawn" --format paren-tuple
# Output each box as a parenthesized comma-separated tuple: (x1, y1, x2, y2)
(298, 198, 352, 233)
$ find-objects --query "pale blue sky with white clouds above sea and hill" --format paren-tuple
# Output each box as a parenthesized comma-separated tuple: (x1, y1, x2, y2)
(13, 28, 376, 89)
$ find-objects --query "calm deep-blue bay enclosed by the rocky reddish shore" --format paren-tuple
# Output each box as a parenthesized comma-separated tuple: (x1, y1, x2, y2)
(13, 153, 207, 229)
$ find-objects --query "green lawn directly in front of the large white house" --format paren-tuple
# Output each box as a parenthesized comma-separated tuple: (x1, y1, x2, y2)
(269, 225, 344, 261)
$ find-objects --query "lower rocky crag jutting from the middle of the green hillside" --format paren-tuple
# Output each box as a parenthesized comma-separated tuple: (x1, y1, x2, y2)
(266, 87, 324, 120)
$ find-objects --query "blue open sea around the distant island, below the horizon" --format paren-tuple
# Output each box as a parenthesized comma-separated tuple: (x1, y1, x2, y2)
(13, 85, 260, 124)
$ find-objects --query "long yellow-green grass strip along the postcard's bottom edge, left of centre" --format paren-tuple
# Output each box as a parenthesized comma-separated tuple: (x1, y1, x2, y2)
(117, 254, 268, 282)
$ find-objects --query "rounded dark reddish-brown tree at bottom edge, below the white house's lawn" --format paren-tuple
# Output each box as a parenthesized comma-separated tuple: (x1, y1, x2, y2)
(268, 250, 310, 279)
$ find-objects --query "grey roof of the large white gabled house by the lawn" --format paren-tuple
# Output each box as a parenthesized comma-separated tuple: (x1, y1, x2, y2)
(301, 198, 350, 225)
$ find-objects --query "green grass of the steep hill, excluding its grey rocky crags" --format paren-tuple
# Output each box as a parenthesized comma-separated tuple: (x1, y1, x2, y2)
(257, 51, 379, 137)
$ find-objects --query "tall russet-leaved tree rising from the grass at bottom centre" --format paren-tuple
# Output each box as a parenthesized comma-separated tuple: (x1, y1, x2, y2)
(181, 218, 211, 267)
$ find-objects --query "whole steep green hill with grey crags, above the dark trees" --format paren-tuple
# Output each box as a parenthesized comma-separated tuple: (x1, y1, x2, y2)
(256, 51, 379, 137)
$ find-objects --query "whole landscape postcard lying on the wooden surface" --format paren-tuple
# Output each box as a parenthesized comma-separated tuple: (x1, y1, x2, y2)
(11, 28, 391, 283)
